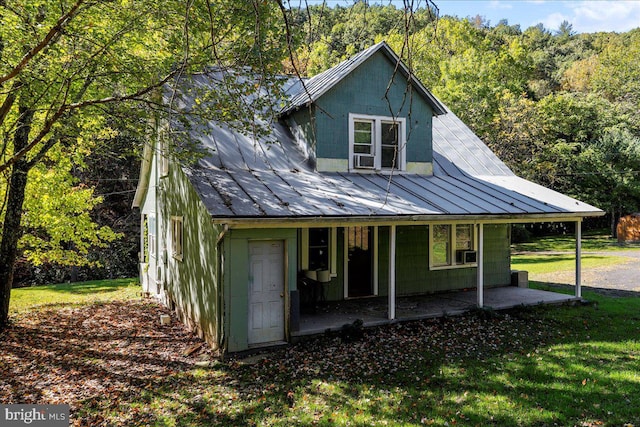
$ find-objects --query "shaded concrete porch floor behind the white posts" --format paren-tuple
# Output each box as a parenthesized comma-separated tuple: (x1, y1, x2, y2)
(291, 286, 577, 337)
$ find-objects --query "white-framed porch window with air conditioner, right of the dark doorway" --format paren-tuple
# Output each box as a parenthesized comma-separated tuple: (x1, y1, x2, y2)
(429, 224, 478, 269)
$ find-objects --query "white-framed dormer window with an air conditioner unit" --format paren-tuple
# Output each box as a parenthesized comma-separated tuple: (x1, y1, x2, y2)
(349, 114, 406, 171)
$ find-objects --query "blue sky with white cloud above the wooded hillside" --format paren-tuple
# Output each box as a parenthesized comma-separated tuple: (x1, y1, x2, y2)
(304, 0, 640, 33)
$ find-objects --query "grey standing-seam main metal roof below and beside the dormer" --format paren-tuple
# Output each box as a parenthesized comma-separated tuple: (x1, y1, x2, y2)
(185, 71, 602, 222)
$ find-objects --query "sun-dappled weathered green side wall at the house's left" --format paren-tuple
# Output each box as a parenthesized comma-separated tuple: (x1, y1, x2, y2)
(158, 165, 222, 346)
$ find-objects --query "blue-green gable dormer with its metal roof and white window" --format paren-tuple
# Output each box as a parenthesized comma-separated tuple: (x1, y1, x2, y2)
(284, 42, 445, 174)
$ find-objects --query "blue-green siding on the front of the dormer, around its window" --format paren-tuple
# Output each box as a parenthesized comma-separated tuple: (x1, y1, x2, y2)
(315, 53, 433, 162)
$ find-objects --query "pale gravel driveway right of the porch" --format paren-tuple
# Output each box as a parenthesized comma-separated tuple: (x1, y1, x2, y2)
(529, 250, 640, 296)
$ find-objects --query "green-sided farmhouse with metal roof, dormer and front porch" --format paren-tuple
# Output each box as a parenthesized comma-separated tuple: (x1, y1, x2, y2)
(134, 42, 602, 352)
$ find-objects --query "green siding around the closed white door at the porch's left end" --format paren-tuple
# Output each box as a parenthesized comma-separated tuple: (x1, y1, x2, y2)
(223, 228, 298, 352)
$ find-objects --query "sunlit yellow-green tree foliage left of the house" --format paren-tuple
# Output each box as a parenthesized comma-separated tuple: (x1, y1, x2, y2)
(0, 0, 288, 290)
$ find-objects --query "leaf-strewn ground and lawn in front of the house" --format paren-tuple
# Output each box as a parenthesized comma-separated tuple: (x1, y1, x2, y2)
(0, 298, 640, 426)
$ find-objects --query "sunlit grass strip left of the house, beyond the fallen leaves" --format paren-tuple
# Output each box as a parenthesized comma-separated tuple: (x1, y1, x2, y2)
(9, 279, 141, 313)
